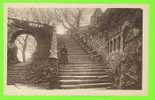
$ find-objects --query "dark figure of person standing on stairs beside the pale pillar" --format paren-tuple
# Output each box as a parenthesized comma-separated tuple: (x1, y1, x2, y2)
(60, 45, 68, 64)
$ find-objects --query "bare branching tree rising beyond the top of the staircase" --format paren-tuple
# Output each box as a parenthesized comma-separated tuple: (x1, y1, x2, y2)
(54, 8, 90, 30)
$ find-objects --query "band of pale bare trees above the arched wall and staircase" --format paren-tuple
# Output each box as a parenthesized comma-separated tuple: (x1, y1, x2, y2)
(8, 8, 93, 30)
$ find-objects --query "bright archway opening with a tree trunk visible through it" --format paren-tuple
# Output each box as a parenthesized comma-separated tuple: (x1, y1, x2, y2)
(15, 34, 37, 62)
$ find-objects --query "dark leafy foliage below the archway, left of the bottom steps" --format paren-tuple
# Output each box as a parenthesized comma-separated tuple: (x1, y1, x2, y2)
(26, 59, 58, 88)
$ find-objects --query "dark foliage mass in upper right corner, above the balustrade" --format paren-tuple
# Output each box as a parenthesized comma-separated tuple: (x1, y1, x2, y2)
(100, 8, 142, 31)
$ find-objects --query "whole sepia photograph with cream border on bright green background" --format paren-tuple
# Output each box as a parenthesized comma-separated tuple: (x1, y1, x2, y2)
(4, 4, 148, 96)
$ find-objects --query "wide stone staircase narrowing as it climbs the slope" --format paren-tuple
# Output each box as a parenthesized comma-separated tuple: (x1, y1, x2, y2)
(58, 35, 112, 89)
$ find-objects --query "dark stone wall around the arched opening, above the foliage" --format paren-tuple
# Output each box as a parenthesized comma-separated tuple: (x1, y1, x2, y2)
(7, 19, 53, 62)
